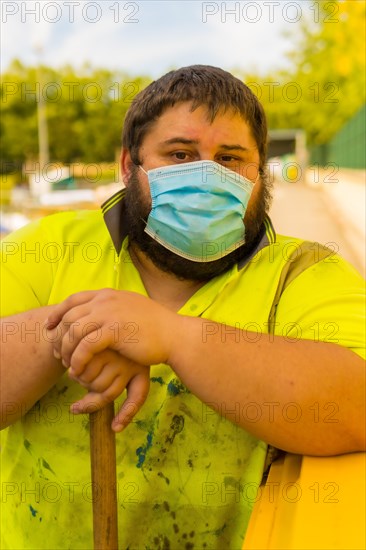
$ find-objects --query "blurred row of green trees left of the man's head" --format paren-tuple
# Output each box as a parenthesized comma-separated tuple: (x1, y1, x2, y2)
(0, 60, 149, 171)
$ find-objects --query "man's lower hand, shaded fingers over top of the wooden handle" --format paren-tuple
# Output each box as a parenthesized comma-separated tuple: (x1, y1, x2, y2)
(69, 350, 150, 432)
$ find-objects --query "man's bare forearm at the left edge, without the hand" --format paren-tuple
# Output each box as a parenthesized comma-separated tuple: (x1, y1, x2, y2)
(0, 306, 65, 429)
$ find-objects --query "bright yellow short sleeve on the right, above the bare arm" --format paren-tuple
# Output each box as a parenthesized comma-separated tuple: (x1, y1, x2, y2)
(275, 256, 366, 358)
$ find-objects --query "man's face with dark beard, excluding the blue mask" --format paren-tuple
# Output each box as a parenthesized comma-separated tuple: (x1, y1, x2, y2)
(124, 102, 269, 281)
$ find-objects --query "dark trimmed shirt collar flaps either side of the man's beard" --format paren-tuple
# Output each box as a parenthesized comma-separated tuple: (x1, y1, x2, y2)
(102, 189, 276, 269)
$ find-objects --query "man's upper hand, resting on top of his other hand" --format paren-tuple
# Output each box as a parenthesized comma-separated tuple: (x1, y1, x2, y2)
(46, 289, 180, 377)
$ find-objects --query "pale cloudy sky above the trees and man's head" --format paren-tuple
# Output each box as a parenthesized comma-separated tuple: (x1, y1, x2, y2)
(0, 0, 316, 78)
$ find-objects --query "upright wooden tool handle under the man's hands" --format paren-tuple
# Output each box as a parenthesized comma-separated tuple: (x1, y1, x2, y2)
(90, 403, 118, 550)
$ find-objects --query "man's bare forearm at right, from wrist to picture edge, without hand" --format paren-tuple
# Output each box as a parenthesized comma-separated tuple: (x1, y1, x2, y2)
(170, 317, 365, 455)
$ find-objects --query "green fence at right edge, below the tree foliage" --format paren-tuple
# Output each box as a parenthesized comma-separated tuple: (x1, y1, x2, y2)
(310, 105, 366, 169)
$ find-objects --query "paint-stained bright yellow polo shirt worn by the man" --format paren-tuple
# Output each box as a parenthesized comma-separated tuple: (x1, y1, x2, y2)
(1, 201, 364, 550)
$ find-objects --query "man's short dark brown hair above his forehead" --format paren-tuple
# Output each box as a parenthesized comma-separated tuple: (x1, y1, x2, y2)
(122, 65, 267, 172)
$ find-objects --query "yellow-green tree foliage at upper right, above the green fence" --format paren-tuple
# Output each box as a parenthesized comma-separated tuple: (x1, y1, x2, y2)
(243, 0, 366, 144)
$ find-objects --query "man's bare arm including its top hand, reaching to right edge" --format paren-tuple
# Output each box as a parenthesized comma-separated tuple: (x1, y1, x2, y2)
(48, 289, 365, 455)
